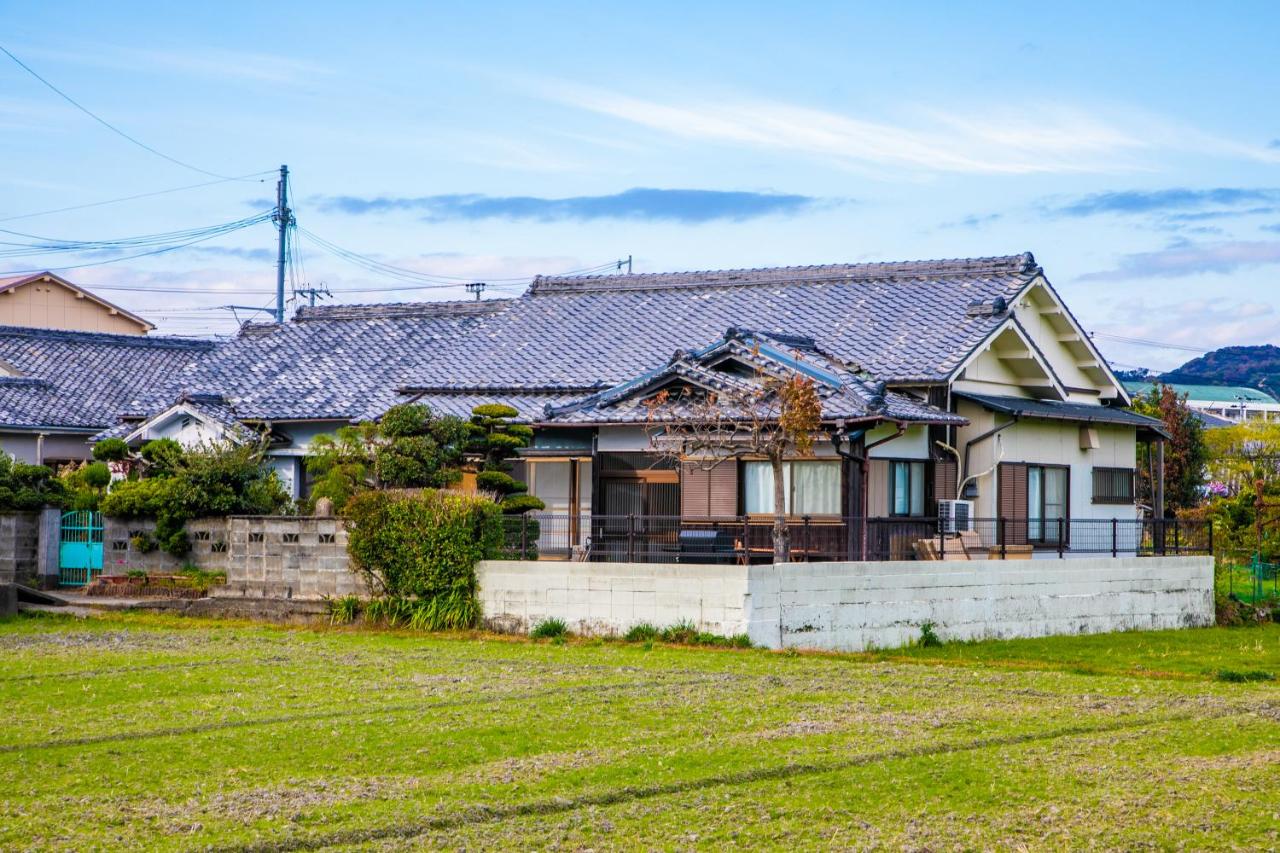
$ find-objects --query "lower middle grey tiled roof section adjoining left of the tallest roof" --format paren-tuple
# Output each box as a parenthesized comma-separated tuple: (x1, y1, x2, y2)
(127, 300, 507, 421)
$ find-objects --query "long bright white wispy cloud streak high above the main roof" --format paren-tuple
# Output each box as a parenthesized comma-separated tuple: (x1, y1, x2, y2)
(535, 82, 1151, 174)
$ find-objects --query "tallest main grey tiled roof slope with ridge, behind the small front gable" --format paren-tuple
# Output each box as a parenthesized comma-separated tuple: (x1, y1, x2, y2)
(416, 254, 1041, 387)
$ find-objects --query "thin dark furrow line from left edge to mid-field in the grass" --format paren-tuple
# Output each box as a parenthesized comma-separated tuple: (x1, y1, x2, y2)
(0, 678, 724, 754)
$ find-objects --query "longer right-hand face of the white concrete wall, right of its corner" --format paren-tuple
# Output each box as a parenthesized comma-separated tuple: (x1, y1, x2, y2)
(751, 557, 1213, 651)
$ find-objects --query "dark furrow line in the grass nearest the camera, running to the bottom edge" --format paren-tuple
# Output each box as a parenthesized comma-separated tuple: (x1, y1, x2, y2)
(220, 708, 1252, 853)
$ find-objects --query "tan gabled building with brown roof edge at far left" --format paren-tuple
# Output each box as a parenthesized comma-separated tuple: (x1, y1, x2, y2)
(0, 273, 155, 334)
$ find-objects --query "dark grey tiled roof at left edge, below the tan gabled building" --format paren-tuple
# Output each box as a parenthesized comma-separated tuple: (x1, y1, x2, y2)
(0, 327, 215, 430)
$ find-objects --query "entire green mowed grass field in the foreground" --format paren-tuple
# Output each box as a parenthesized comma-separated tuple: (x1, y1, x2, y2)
(0, 615, 1280, 850)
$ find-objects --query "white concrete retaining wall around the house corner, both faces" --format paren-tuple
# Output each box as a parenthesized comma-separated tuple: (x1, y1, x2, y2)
(477, 557, 1213, 651)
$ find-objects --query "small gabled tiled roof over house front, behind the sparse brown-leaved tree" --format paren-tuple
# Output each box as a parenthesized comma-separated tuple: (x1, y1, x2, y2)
(543, 327, 968, 425)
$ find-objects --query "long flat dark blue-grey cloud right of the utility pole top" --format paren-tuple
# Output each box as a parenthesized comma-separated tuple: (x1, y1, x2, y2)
(314, 187, 829, 224)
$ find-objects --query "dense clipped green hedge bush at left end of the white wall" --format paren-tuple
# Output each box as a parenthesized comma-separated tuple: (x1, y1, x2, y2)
(343, 491, 503, 628)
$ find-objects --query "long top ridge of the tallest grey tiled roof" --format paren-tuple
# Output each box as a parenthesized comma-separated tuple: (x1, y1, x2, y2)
(529, 252, 1041, 296)
